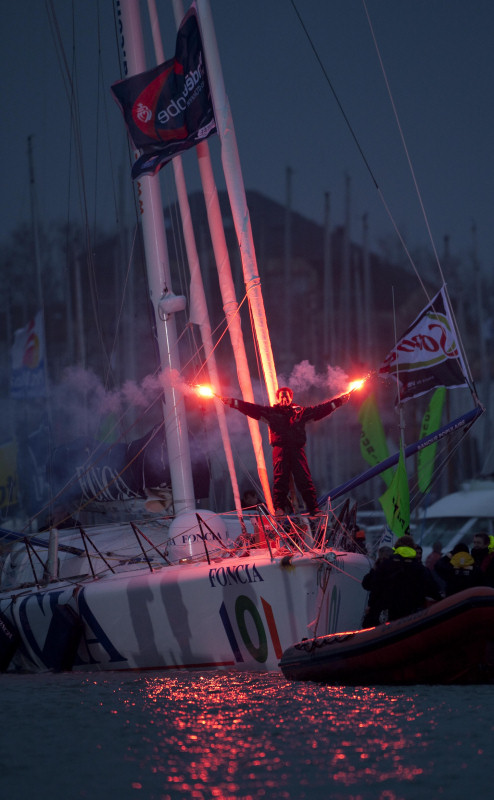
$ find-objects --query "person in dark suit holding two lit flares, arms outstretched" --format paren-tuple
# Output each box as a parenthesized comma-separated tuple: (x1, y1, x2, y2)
(221, 386, 351, 516)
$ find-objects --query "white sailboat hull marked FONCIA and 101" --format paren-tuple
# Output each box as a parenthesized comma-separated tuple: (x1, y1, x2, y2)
(0, 520, 369, 672)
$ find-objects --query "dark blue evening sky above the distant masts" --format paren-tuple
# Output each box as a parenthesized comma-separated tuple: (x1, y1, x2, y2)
(0, 0, 494, 270)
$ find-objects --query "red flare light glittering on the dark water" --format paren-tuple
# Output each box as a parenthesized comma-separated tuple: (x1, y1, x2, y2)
(113, 673, 430, 800)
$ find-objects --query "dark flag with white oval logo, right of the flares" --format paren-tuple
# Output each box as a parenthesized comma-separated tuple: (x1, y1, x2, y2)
(379, 287, 468, 401)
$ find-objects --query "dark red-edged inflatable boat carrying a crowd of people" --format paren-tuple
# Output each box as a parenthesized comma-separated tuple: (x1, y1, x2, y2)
(279, 587, 494, 686)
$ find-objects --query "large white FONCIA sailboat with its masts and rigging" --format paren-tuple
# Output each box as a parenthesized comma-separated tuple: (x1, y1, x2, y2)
(0, 0, 486, 672)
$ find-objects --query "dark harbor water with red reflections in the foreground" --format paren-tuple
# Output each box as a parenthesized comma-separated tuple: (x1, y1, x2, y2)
(0, 672, 494, 800)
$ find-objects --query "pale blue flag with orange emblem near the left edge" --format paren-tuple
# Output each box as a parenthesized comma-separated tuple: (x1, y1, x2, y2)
(10, 311, 46, 400)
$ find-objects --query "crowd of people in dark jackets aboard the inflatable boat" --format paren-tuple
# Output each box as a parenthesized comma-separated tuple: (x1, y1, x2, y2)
(362, 532, 494, 628)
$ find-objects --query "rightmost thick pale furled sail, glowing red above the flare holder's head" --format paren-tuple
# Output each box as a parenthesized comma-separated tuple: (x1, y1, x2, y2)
(197, 0, 278, 403)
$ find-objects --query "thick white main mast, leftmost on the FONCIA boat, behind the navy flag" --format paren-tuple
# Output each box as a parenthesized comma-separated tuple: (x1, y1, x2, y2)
(115, 0, 195, 514)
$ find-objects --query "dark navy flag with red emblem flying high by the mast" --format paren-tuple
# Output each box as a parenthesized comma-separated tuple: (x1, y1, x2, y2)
(111, 8, 216, 178)
